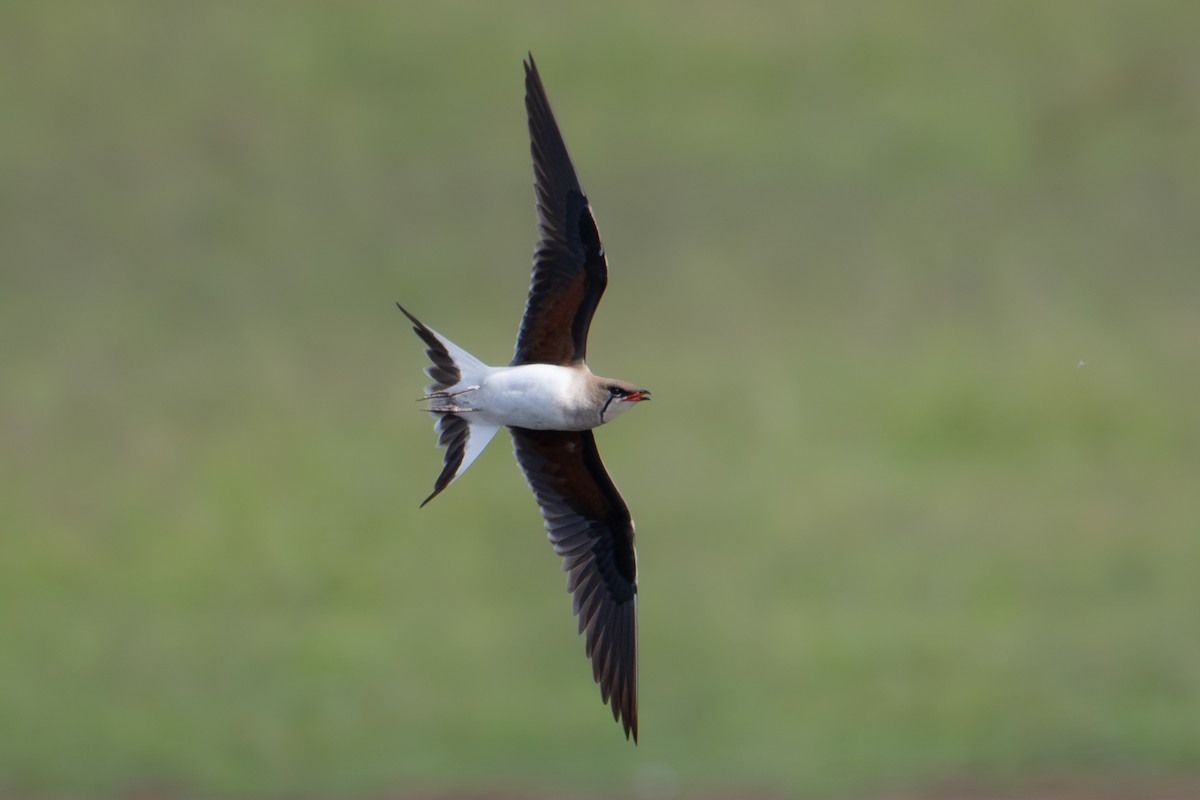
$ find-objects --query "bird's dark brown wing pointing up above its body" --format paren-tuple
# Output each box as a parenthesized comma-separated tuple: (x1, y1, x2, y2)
(512, 55, 608, 366)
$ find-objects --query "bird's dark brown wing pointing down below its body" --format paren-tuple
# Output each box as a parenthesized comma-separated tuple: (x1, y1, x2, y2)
(509, 428, 637, 742)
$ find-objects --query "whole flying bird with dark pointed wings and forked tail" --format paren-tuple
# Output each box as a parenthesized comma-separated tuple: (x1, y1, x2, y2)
(396, 55, 650, 742)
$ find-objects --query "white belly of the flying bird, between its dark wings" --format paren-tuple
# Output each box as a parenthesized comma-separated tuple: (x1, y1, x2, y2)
(455, 363, 600, 431)
